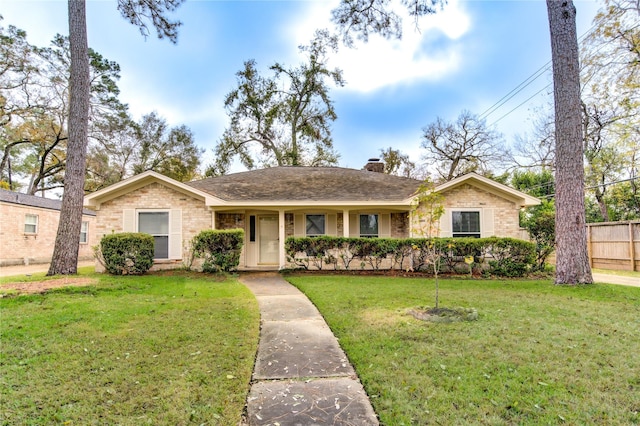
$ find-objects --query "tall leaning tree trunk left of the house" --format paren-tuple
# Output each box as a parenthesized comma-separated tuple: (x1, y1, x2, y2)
(47, 0, 90, 275)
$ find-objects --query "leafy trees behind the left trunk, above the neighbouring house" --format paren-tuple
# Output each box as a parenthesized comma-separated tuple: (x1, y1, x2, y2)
(0, 26, 202, 194)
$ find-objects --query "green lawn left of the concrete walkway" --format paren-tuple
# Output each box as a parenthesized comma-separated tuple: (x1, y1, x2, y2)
(0, 272, 259, 425)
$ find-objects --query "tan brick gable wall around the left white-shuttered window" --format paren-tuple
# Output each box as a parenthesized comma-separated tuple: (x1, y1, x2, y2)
(96, 183, 210, 261)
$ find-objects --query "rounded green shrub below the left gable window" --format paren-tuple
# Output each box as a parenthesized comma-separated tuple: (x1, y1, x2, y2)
(100, 232, 155, 275)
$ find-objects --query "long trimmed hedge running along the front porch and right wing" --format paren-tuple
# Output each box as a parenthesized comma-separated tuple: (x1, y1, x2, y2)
(285, 236, 535, 277)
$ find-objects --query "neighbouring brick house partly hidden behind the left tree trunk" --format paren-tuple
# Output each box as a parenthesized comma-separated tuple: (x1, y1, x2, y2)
(0, 189, 97, 266)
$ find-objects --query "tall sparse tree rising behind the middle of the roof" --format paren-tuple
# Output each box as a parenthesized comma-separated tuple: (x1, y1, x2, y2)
(206, 31, 344, 176)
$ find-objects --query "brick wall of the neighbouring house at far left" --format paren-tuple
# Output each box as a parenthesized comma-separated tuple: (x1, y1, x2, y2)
(0, 203, 98, 266)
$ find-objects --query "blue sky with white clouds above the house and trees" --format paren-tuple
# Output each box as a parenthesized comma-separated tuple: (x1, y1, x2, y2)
(0, 0, 601, 173)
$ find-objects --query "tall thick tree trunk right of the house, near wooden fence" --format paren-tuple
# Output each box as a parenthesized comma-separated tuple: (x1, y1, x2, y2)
(547, 0, 593, 284)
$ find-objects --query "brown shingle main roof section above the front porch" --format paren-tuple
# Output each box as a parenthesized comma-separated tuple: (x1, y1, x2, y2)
(187, 166, 422, 202)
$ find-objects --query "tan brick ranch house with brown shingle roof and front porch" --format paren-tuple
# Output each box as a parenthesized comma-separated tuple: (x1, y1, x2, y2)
(85, 162, 540, 270)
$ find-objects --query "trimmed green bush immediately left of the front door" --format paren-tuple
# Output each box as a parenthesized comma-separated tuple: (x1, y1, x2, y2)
(192, 229, 244, 272)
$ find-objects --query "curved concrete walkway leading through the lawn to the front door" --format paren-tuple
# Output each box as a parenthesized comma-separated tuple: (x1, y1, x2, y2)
(240, 273, 379, 426)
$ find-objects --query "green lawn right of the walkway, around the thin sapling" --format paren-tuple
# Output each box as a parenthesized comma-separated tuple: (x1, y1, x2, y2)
(288, 275, 640, 425)
